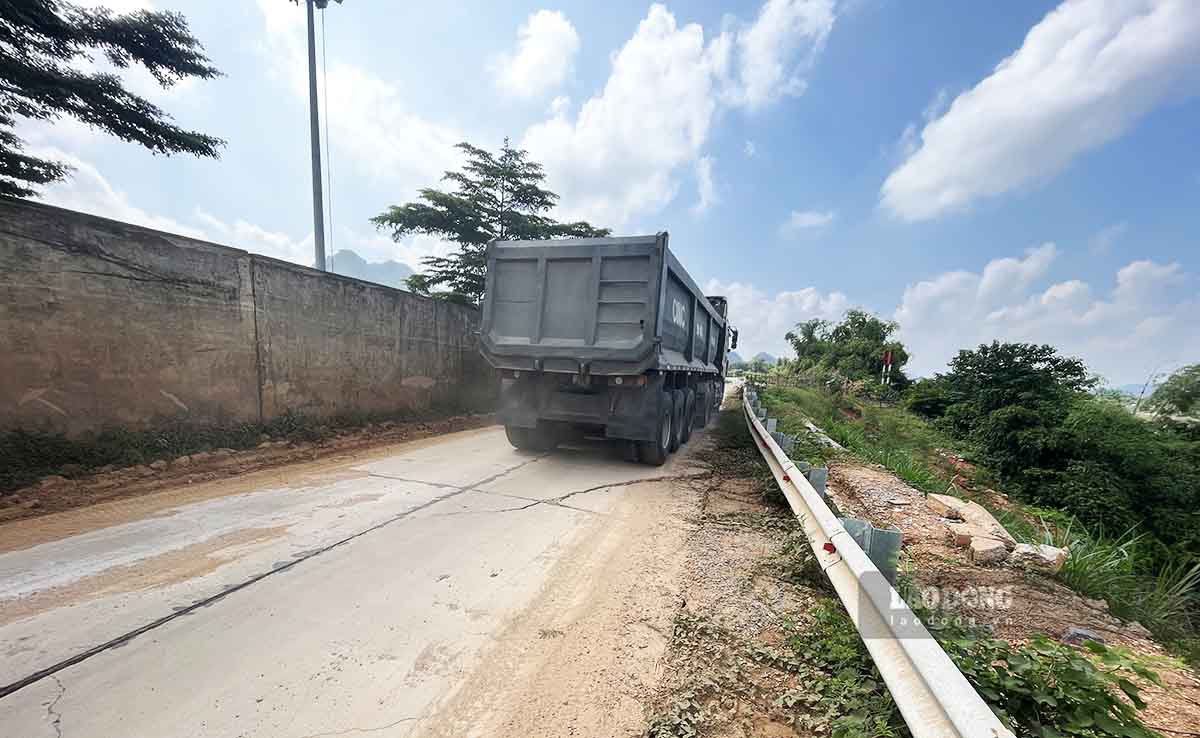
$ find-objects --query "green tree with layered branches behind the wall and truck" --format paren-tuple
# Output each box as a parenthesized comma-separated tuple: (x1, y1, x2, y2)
(371, 138, 608, 302)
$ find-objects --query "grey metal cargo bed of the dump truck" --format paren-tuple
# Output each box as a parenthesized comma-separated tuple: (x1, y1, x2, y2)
(480, 233, 725, 374)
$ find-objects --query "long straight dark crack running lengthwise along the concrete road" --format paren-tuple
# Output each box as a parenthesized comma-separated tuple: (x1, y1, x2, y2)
(0, 454, 546, 700)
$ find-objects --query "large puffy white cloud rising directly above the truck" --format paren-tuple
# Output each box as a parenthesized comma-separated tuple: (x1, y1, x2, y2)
(521, 0, 833, 227)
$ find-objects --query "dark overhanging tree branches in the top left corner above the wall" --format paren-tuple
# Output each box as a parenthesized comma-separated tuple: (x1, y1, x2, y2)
(0, 0, 224, 197)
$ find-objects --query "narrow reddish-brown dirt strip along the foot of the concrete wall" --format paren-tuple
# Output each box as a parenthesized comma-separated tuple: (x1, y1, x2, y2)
(0, 415, 496, 523)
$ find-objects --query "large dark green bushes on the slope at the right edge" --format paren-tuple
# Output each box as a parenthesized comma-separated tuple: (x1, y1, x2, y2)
(931, 342, 1200, 564)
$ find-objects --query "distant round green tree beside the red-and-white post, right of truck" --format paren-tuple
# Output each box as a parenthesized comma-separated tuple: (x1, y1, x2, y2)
(786, 310, 908, 388)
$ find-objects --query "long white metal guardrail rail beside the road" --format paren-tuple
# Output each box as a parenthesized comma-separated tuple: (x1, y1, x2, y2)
(742, 385, 1014, 738)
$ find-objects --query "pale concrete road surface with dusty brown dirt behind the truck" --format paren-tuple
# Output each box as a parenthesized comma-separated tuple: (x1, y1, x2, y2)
(0, 427, 703, 738)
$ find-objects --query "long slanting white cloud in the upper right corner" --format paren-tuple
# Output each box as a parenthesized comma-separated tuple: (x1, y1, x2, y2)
(881, 0, 1200, 221)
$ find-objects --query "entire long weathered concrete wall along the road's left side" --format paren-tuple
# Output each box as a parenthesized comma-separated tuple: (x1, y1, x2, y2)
(0, 199, 493, 436)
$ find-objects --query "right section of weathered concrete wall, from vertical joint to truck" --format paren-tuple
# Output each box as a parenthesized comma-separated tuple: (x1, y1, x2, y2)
(253, 257, 492, 416)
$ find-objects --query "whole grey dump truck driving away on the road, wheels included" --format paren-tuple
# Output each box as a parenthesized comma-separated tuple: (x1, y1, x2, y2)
(479, 232, 737, 466)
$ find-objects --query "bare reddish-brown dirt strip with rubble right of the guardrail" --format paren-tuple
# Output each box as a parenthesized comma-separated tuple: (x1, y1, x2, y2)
(828, 461, 1200, 736)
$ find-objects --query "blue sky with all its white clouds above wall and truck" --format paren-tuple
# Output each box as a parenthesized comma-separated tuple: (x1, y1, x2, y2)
(28, 0, 1200, 384)
